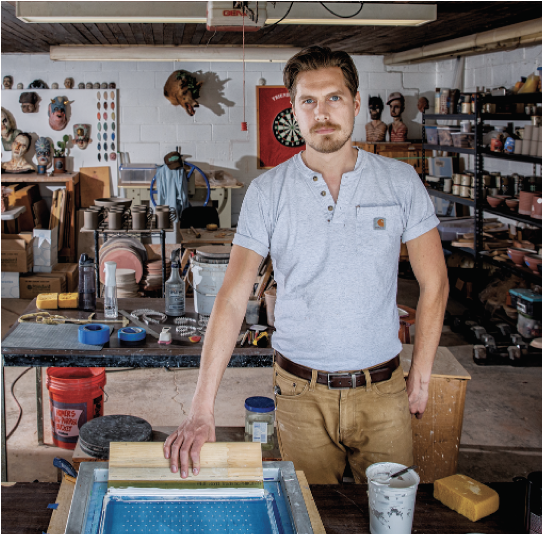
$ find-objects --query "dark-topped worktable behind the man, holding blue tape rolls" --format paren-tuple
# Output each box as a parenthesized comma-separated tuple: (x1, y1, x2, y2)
(1, 298, 273, 481)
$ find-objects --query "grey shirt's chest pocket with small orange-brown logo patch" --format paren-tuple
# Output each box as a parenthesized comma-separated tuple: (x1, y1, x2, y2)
(356, 205, 403, 255)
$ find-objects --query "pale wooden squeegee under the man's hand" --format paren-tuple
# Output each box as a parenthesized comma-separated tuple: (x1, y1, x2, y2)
(108, 442, 263, 489)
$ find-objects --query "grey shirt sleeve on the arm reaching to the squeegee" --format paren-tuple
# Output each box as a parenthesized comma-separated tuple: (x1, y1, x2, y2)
(233, 182, 271, 258)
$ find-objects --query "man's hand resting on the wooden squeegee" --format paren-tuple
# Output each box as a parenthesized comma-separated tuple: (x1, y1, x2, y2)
(164, 413, 216, 478)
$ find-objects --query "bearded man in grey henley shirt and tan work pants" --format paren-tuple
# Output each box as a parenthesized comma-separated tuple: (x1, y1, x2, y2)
(164, 47, 448, 483)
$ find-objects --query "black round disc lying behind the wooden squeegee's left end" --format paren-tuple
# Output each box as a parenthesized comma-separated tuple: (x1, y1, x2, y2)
(79, 415, 152, 460)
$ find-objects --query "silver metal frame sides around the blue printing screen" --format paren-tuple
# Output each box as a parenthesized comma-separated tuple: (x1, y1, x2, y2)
(65, 462, 313, 534)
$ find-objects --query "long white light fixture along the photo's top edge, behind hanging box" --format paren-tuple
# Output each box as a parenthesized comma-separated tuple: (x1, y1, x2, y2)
(16, 1, 437, 26)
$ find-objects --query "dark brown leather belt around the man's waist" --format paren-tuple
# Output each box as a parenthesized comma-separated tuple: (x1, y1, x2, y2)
(275, 351, 400, 389)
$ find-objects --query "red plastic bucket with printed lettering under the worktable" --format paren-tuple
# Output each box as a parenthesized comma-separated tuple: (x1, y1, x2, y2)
(47, 367, 106, 450)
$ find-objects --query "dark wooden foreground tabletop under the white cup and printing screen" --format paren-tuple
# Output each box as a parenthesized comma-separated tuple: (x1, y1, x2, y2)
(2, 482, 523, 534)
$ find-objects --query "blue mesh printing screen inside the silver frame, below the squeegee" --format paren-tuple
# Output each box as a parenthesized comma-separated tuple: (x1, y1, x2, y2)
(85, 481, 294, 534)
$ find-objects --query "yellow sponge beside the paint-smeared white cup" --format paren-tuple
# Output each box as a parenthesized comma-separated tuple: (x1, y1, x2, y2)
(433, 475, 499, 521)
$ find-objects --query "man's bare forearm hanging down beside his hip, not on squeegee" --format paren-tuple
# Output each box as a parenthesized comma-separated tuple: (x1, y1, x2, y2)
(412, 280, 448, 383)
